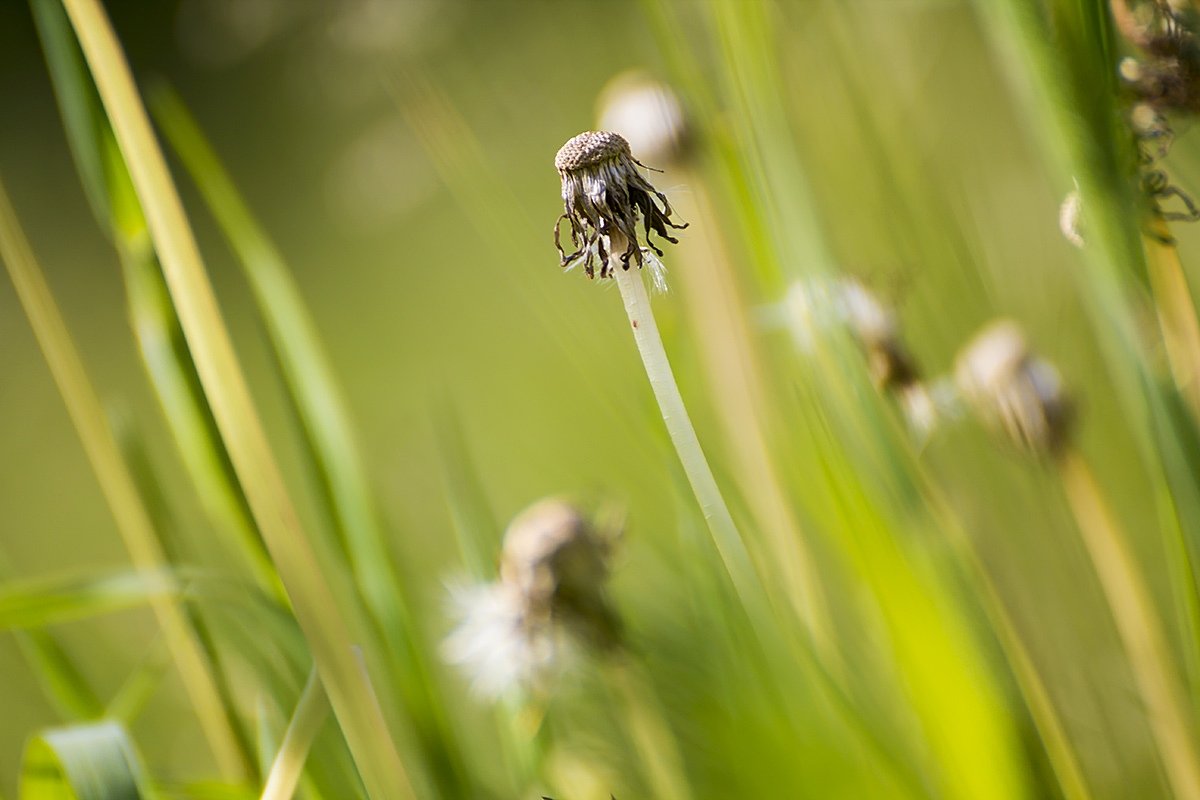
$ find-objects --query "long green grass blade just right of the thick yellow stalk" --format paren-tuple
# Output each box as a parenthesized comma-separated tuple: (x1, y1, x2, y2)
(150, 84, 472, 796)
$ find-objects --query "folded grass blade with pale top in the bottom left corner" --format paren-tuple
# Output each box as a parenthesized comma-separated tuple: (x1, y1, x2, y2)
(20, 722, 155, 800)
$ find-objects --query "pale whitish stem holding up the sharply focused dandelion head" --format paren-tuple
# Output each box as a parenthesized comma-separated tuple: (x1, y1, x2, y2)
(610, 235, 761, 609)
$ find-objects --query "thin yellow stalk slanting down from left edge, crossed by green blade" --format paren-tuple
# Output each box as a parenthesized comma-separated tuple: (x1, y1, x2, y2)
(0, 173, 248, 777)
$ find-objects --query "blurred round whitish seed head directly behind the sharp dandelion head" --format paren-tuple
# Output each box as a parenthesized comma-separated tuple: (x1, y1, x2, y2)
(596, 70, 692, 167)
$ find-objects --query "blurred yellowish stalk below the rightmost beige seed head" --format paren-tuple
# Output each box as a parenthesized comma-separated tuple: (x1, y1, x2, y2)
(1058, 451, 1200, 800)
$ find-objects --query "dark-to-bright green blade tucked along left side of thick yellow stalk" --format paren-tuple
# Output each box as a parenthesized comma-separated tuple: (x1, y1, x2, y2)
(31, 0, 282, 599)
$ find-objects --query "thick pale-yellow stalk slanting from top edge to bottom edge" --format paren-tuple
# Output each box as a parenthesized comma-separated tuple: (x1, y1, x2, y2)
(64, 0, 415, 800)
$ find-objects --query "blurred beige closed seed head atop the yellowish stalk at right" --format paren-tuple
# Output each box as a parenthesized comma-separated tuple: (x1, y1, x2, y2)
(955, 320, 1073, 453)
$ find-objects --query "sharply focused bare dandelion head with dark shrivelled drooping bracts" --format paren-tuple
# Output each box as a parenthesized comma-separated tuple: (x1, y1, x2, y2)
(554, 131, 688, 278)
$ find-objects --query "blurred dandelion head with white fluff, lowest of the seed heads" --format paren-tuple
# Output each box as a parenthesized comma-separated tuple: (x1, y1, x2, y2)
(442, 499, 620, 698)
